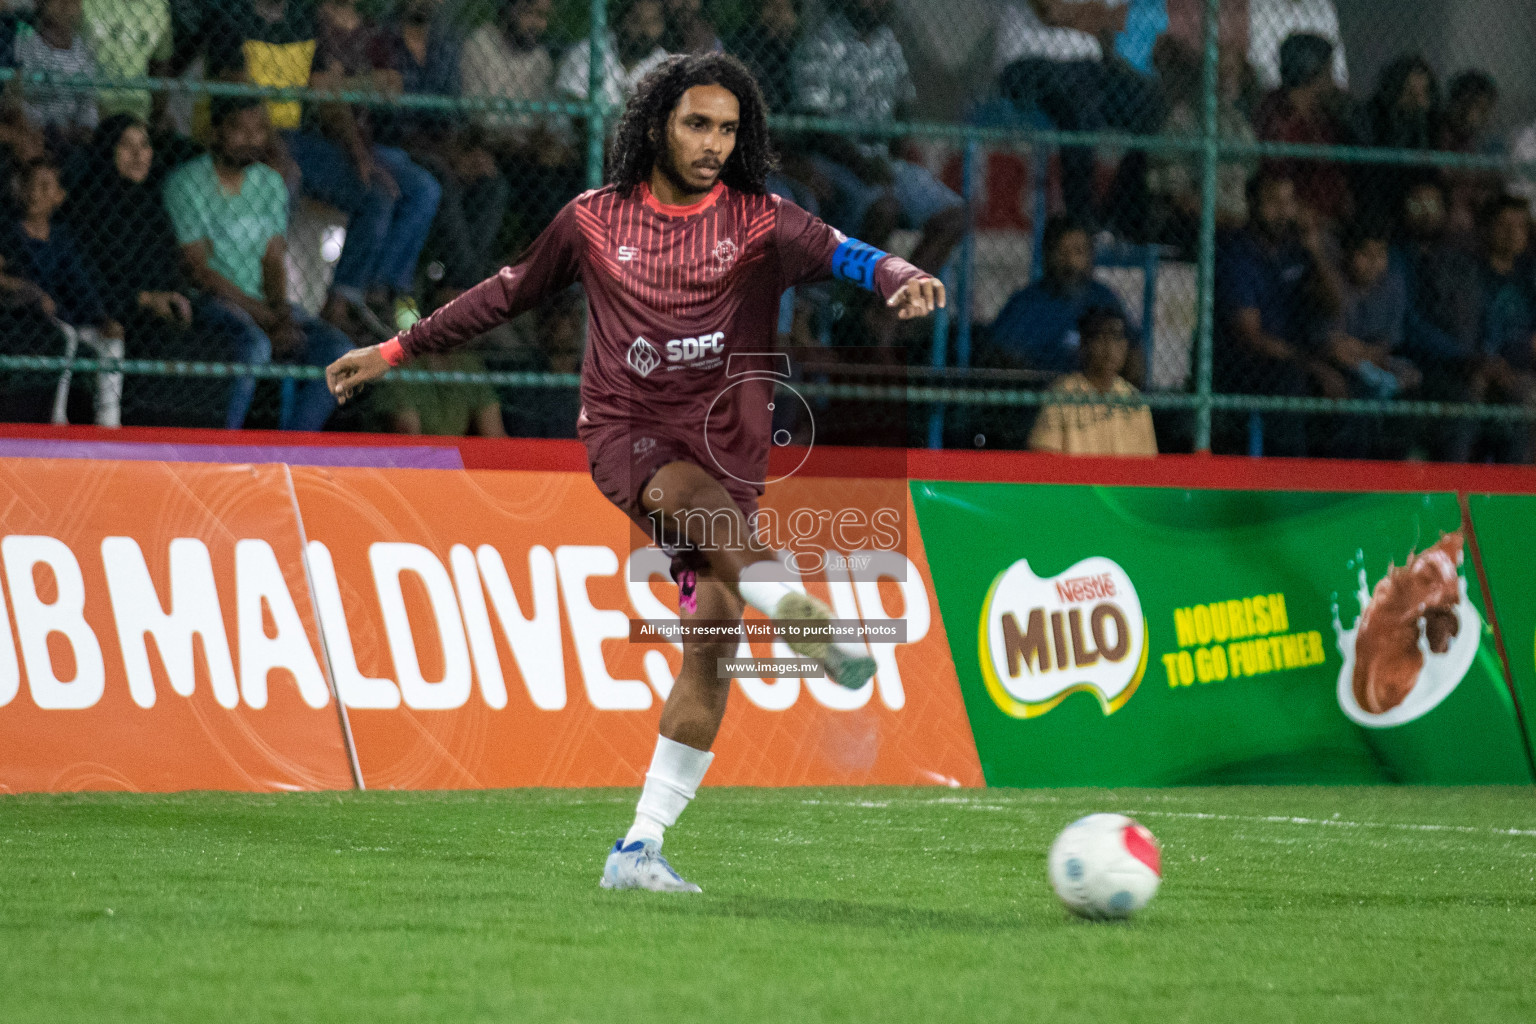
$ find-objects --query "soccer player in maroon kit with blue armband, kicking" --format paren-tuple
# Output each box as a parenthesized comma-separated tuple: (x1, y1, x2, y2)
(327, 54, 945, 892)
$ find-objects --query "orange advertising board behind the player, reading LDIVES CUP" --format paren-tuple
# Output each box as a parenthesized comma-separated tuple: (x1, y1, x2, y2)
(292, 467, 982, 789)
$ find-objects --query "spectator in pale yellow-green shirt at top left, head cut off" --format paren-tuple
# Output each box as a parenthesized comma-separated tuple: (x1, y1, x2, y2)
(81, 0, 175, 124)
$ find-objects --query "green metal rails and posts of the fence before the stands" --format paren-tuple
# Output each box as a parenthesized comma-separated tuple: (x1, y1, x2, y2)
(0, 0, 1536, 450)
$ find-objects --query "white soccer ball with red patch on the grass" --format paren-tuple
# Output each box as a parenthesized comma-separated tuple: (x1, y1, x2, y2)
(1048, 814, 1163, 921)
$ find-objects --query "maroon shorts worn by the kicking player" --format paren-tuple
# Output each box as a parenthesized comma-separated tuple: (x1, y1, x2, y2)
(578, 424, 757, 583)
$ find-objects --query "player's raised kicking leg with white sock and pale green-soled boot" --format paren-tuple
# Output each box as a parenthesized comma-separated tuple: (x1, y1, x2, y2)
(641, 461, 876, 689)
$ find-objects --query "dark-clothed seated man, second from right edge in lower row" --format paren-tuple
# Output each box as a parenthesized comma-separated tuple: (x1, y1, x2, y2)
(1392, 177, 1482, 462)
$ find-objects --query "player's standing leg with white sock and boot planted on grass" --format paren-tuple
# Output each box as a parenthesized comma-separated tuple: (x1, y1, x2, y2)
(602, 570, 742, 892)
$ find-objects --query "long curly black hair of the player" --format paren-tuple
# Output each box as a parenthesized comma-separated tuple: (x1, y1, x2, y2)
(608, 54, 779, 197)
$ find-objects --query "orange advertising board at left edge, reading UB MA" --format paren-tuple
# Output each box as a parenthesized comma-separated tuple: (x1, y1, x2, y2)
(0, 459, 353, 792)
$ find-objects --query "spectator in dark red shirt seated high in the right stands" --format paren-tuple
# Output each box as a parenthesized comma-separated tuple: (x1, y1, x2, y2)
(1253, 35, 1353, 224)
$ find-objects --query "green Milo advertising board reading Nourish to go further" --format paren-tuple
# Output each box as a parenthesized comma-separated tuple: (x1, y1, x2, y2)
(912, 481, 1536, 786)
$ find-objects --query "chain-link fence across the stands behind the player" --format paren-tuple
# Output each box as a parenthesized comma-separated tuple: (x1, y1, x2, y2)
(0, 0, 1536, 461)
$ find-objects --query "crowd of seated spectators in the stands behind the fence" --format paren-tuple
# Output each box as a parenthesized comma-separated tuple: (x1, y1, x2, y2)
(0, 0, 1536, 461)
